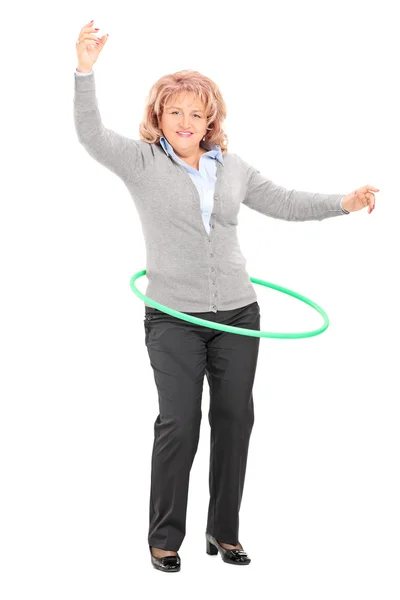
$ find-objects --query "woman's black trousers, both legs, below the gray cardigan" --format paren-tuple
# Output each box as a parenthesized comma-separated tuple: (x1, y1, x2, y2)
(144, 302, 260, 550)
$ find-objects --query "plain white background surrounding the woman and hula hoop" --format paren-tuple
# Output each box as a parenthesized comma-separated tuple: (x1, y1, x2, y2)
(0, 0, 400, 600)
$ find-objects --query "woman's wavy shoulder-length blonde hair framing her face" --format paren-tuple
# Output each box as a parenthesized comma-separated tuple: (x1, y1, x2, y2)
(139, 69, 228, 154)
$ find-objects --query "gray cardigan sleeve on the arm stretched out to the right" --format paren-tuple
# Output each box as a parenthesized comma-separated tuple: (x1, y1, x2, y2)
(242, 161, 350, 221)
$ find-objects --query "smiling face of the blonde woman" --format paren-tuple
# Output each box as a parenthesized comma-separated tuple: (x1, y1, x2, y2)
(160, 92, 207, 156)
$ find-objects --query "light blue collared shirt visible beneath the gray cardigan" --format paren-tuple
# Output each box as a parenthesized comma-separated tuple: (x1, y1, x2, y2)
(160, 136, 224, 235)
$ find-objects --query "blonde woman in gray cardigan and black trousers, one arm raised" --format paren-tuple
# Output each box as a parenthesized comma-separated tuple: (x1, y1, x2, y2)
(74, 21, 378, 572)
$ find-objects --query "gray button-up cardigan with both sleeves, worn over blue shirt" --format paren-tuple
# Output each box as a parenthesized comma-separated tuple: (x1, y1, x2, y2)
(74, 71, 349, 312)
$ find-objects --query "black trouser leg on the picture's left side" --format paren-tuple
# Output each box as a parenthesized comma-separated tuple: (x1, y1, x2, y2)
(145, 311, 206, 550)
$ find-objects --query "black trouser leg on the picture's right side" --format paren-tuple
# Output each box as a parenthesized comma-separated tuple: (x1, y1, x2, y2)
(206, 303, 260, 545)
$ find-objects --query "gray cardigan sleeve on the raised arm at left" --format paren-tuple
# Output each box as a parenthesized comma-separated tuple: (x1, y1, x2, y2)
(74, 71, 149, 181)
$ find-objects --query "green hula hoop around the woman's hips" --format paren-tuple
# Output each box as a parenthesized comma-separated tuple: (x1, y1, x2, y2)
(130, 269, 329, 339)
